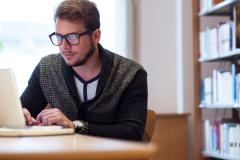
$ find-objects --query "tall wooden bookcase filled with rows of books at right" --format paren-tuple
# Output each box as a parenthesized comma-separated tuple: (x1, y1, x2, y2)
(192, 0, 240, 160)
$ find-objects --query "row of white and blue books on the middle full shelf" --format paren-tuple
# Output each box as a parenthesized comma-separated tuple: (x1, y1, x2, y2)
(200, 64, 240, 107)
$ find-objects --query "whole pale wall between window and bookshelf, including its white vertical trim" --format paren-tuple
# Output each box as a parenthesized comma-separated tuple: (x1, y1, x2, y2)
(138, 0, 193, 113)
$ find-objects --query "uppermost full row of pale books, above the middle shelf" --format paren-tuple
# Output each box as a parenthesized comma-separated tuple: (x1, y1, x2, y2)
(199, 21, 234, 59)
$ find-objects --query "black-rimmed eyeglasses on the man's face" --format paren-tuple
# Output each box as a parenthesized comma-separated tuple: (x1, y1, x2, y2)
(49, 31, 90, 46)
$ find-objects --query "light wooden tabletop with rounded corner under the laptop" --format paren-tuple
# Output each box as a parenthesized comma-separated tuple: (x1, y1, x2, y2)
(0, 134, 156, 160)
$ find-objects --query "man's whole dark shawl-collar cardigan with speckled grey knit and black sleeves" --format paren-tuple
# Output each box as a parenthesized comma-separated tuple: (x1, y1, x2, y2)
(21, 46, 147, 140)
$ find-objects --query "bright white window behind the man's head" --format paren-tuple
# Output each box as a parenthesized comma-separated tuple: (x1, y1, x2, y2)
(0, 0, 127, 94)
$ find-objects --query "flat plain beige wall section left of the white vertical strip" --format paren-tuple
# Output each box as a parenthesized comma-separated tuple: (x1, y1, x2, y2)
(139, 0, 177, 112)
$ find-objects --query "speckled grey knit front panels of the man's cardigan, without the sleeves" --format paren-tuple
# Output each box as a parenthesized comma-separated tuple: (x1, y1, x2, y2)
(40, 54, 143, 123)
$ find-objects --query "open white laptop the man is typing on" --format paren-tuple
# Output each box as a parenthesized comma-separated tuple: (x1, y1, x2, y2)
(0, 69, 74, 136)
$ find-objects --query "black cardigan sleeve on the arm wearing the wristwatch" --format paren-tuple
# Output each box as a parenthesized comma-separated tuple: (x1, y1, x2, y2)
(88, 70, 148, 140)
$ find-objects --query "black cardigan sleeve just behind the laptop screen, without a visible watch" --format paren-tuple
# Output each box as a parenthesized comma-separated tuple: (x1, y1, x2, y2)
(20, 64, 47, 117)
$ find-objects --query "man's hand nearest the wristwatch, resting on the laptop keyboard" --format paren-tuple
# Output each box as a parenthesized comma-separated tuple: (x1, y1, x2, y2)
(36, 104, 74, 128)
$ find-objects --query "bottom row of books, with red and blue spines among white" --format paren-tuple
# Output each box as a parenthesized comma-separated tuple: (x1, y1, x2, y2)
(203, 119, 240, 158)
